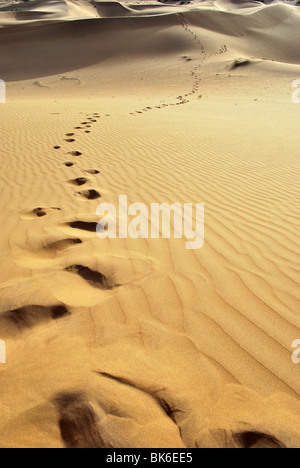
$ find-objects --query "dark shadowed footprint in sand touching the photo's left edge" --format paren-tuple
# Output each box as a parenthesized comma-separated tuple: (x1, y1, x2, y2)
(0, 305, 70, 335)
